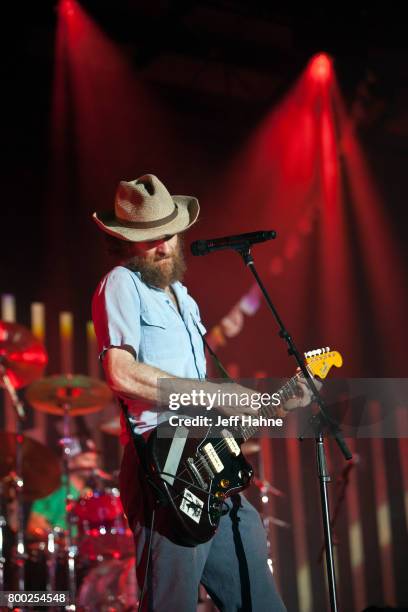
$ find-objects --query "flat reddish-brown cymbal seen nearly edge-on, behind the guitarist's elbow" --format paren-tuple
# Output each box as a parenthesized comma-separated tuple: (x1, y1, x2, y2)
(26, 374, 112, 416)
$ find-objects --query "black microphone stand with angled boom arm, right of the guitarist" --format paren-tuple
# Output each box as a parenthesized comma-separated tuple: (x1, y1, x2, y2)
(234, 242, 352, 612)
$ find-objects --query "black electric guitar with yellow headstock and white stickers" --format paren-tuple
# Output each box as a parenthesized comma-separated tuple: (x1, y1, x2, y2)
(147, 348, 343, 546)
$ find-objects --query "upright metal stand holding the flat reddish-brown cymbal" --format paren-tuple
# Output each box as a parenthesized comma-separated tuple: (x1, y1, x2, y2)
(59, 400, 78, 610)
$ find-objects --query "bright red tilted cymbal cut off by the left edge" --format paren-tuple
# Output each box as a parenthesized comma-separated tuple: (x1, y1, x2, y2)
(0, 321, 48, 389)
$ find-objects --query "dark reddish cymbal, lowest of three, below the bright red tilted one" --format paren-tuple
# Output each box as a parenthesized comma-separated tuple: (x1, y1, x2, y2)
(0, 431, 61, 501)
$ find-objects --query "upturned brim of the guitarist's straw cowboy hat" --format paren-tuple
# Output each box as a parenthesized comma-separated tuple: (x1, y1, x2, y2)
(92, 196, 200, 242)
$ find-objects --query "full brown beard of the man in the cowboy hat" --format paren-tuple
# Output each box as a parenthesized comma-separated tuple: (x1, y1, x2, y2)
(126, 238, 186, 289)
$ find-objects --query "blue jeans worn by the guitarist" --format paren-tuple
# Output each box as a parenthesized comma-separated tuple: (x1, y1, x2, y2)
(120, 443, 285, 612)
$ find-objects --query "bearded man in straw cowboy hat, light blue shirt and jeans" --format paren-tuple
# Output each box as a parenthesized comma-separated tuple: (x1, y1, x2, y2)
(92, 174, 310, 612)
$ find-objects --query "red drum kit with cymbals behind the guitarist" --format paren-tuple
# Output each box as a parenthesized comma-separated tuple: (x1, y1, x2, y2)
(0, 321, 137, 610)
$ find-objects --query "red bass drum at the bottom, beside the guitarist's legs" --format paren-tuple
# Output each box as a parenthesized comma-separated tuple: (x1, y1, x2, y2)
(77, 559, 139, 612)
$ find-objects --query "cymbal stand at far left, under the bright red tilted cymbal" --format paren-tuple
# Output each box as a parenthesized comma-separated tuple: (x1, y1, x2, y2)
(0, 362, 26, 591)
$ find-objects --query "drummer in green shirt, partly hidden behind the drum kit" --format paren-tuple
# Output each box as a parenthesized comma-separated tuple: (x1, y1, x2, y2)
(27, 438, 99, 537)
